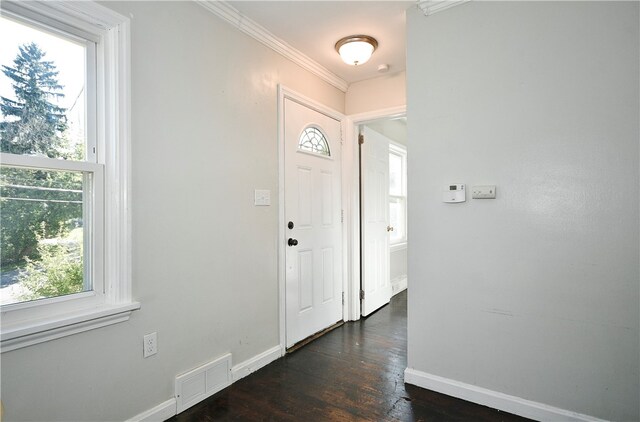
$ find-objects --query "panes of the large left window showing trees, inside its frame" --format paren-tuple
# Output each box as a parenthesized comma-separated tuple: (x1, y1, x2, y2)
(0, 16, 96, 305)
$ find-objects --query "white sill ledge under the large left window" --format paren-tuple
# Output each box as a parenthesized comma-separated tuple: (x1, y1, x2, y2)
(0, 302, 140, 353)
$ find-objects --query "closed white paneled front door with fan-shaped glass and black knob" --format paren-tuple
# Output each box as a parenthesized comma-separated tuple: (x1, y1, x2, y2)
(284, 98, 342, 347)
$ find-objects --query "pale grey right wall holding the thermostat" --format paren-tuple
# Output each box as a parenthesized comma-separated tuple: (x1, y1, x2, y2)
(407, 2, 640, 421)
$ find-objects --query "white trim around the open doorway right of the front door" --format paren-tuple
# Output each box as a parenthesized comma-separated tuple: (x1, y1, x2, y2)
(342, 105, 407, 321)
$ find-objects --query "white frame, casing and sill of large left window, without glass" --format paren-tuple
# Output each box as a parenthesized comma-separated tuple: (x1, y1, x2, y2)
(0, 1, 140, 353)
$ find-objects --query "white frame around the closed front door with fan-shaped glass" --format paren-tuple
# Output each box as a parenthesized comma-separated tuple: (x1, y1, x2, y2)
(278, 85, 348, 356)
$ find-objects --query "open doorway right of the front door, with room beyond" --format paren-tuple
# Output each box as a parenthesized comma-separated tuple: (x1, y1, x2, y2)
(358, 116, 408, 316)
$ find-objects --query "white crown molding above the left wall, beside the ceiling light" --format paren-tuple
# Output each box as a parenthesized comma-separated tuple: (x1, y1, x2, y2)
(194, 0, 349, 92)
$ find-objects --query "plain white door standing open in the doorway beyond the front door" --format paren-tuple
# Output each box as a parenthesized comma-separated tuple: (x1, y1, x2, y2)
(360, 126, 392, 316)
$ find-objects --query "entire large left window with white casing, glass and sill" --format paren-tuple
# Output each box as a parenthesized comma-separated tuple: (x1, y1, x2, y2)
(0, 1, 139, 352)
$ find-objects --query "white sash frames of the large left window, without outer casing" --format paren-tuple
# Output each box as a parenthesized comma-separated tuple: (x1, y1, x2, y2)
(0, 2, 105, 310)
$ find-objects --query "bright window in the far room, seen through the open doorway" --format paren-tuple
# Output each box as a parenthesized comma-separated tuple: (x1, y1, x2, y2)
(389, 144, 407, 247)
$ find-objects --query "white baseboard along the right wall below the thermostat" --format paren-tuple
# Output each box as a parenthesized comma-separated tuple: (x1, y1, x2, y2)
(404, 368, 605, 422)
